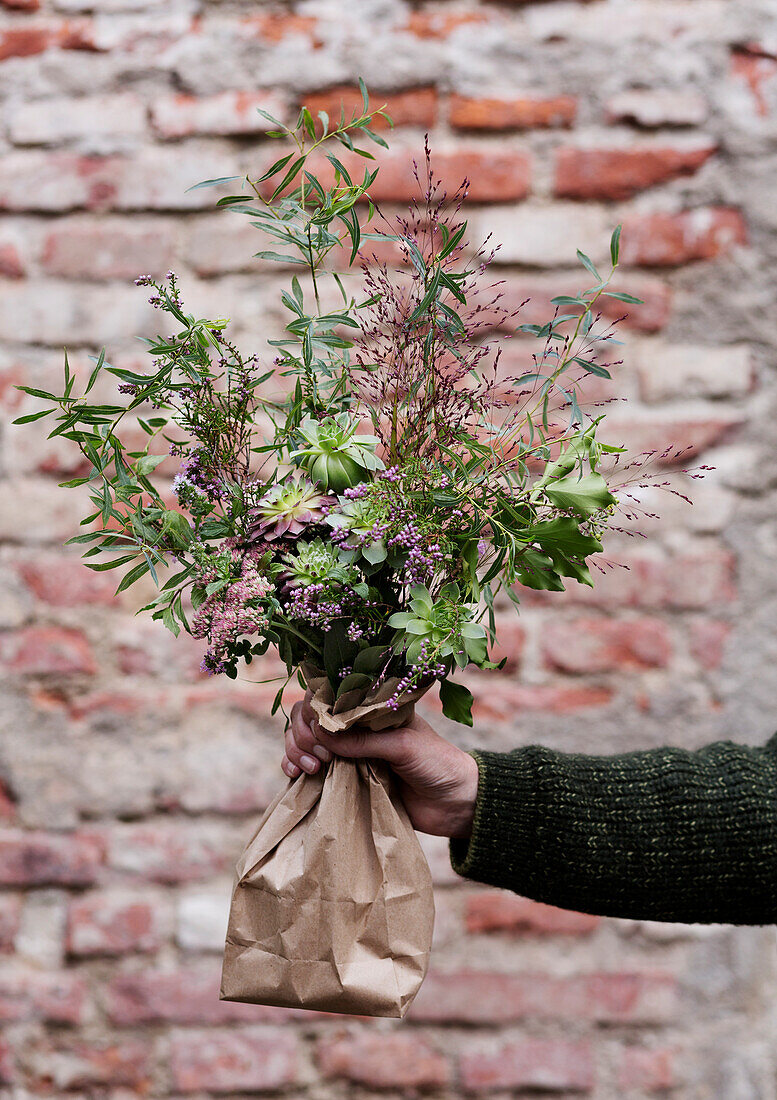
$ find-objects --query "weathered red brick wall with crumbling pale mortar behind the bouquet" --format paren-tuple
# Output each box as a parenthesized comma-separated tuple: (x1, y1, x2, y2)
(0, 0, 777, 1100)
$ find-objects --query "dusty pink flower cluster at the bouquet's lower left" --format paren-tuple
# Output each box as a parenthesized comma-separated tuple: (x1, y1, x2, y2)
(191, 549, 273, 673)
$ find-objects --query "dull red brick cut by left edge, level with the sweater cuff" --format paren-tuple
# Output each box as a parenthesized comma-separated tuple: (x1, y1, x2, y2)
(0, 829, 103, 887)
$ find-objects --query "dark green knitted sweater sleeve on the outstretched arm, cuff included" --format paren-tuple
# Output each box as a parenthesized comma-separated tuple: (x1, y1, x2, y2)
(450, 735, 777, 924)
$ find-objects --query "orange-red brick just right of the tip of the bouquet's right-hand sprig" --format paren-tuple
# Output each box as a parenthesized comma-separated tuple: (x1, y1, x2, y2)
(621, 207, 747, 267)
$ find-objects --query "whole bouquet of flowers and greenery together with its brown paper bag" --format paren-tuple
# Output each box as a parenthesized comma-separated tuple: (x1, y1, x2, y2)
(18, 84, 638, 1015)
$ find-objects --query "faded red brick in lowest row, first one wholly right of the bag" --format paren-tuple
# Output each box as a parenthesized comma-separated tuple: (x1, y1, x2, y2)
(460, 1038, 594, 1092)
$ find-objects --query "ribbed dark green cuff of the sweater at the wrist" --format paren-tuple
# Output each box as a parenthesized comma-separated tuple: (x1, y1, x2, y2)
(450, 748, 536, 890)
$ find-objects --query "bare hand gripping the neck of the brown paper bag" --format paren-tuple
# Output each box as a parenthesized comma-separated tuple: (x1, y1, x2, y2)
(281, 692, 478, 837)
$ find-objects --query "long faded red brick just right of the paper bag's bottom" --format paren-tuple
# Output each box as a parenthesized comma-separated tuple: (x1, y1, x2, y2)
(408, 969, 679, 1024)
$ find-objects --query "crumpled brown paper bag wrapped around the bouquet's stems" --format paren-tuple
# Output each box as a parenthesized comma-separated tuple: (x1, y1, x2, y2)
(220, 678, 435, 1016)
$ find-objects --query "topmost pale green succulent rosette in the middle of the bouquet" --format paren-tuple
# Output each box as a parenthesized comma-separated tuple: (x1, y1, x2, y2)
(292, 413, 384, 493)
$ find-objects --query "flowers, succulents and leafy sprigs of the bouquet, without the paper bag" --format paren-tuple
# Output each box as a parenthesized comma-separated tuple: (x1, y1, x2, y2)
(19, 85, 637, 728)
